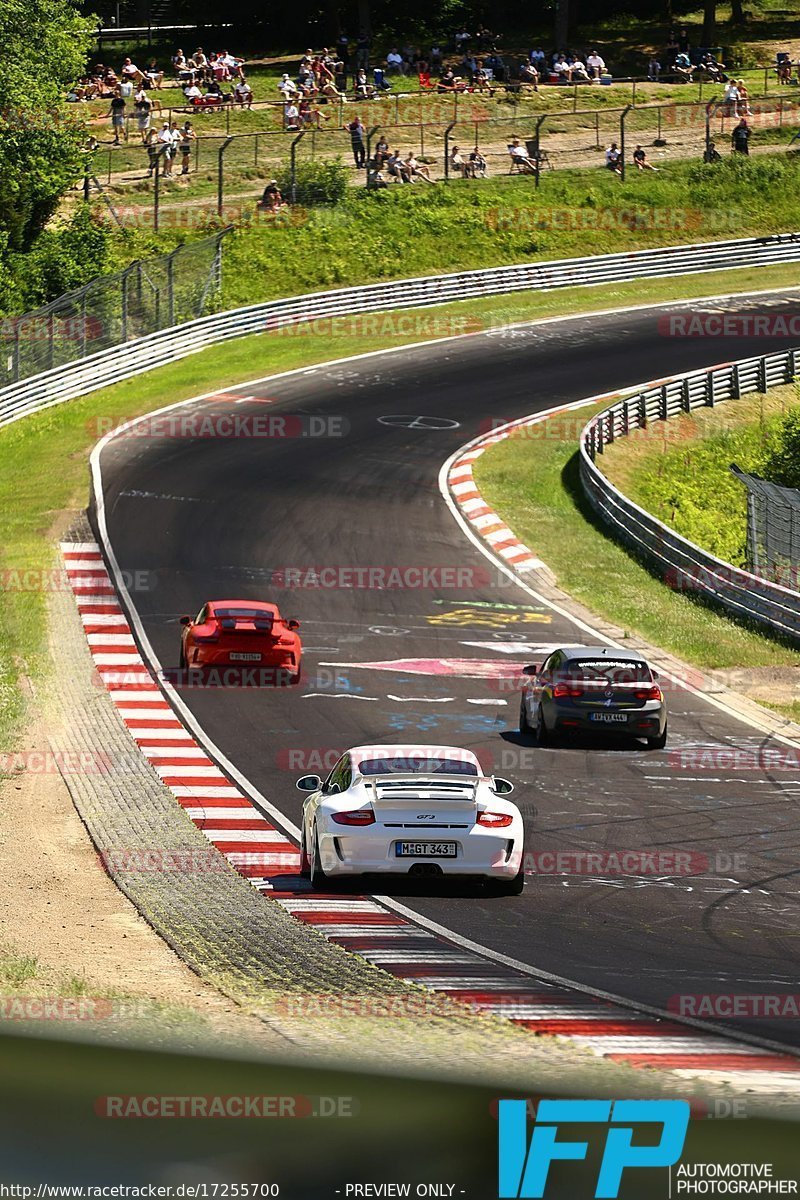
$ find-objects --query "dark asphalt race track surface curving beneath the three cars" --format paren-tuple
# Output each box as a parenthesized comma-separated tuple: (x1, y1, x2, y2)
(102, 295, 800, 1045)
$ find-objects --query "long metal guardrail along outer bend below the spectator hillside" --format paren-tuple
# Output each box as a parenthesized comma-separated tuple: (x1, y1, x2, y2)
(0, 233, 800, 426)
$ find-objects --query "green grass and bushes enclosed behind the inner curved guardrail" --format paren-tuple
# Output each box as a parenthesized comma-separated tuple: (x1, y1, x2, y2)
(603, 386, 798, 566)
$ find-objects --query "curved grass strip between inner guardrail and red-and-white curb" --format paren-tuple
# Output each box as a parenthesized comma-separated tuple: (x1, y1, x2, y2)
(475, 393, 798, 668)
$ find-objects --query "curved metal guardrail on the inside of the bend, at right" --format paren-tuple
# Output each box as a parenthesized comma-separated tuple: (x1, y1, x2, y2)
(579, 349, 800, 642)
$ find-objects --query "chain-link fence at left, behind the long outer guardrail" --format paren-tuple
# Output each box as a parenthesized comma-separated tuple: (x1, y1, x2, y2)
(0, 229, 230, 386)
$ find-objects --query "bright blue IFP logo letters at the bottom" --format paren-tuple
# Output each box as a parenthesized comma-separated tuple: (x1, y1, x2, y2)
(498, 1100, 690, 1200)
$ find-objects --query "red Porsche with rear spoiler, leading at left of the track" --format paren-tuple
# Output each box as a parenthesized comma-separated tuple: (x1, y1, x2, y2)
(180, 600, 302, 684)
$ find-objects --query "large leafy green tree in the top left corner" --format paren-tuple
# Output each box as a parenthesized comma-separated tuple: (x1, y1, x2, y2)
(0, 0, 97, 251)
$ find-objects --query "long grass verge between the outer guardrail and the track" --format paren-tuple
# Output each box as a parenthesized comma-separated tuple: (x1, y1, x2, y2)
(0, 265, 796, 749)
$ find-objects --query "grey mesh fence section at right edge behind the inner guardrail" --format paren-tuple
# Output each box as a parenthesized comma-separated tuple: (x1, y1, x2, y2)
(730, 464, 800, 590)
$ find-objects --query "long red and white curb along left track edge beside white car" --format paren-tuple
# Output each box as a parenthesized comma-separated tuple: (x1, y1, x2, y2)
(61, 544, 800, 1088)
